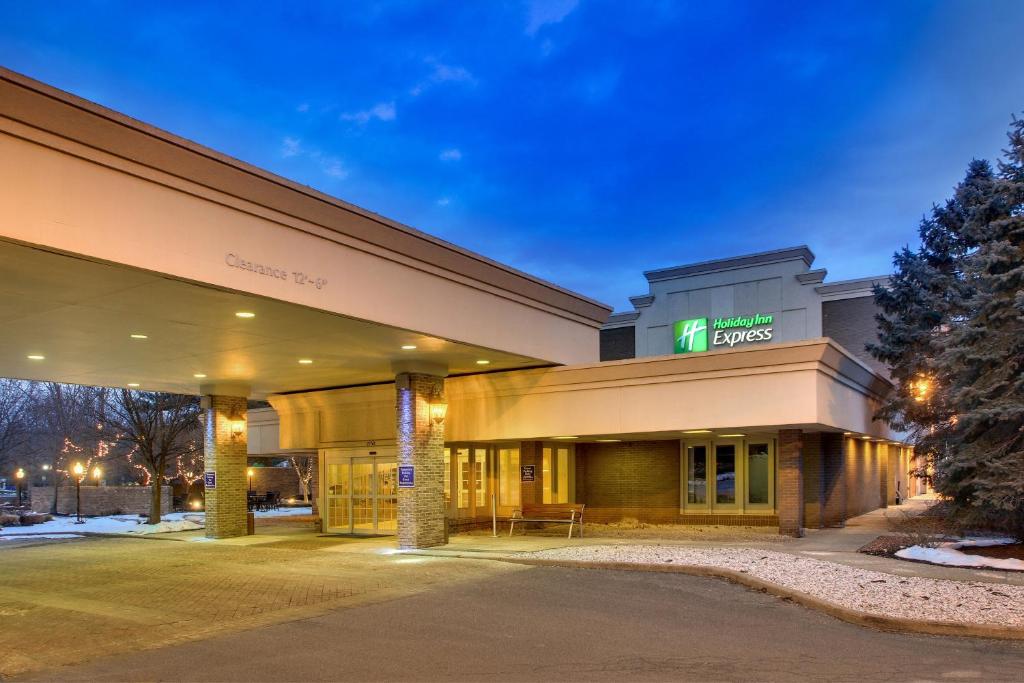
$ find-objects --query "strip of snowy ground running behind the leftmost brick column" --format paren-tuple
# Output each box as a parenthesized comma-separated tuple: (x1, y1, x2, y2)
(0, 508, 312, 540)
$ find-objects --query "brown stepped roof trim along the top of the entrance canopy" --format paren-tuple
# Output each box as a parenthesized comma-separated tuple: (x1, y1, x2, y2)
(0, 68, 611, 324)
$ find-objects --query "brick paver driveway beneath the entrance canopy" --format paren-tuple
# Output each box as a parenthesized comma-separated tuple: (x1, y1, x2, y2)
(0, 528, 522, 679)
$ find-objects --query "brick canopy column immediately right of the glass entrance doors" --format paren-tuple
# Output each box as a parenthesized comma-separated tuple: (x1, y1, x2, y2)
(395, 373, 446, 548)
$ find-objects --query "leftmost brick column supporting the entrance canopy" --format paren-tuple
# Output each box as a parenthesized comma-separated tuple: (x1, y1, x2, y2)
(203, 396, 248, 539)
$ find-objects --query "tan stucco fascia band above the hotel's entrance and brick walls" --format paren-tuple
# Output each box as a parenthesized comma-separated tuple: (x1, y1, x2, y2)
(270, 340, 890, 448)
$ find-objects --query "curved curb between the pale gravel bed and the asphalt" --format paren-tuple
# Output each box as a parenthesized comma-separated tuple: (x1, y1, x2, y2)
(423, 555, 1024, 640)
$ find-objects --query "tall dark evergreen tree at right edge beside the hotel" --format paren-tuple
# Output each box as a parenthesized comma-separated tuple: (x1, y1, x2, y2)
(869, 114, 1024, 536)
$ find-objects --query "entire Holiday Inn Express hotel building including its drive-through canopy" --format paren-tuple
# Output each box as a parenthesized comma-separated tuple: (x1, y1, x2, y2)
(0, 70, 909, 548)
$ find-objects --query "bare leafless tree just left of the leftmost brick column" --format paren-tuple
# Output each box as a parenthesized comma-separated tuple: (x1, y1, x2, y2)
(102, 389, 200, 524)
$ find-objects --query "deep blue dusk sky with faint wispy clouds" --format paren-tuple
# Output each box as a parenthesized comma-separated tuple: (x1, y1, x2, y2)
(0, 0, 1024, 309)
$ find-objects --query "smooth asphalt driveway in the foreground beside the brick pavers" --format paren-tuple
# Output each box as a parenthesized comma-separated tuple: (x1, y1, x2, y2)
(19, 567, 1024, 681)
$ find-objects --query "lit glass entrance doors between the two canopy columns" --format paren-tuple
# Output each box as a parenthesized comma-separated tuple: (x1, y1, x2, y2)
(323, 449, 398, 535)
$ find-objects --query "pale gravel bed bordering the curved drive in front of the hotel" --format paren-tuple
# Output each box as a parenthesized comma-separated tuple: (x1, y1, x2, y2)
(525, 545, 1024, 627)
